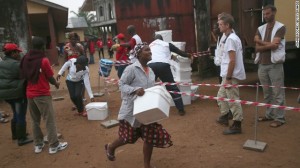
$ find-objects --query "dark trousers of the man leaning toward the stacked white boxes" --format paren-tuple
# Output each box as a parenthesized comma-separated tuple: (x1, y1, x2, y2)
(149, 62, 184, 110)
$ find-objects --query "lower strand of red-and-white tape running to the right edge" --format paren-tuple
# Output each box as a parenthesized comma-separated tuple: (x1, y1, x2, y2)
(169, 91, 300, 112)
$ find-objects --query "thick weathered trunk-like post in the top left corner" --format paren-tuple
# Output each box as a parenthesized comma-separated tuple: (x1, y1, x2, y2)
(0, 0, 30, 53)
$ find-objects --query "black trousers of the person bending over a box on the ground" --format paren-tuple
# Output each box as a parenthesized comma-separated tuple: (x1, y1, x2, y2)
(66, 80, 84, 113)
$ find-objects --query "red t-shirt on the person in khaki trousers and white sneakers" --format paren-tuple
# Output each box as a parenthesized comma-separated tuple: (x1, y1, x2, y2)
(26, 58, 54, 99)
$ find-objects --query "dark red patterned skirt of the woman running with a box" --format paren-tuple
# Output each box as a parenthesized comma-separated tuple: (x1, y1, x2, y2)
(119, 120, 173, 148)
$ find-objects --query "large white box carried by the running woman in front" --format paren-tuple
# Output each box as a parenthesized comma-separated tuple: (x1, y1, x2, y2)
(133, 86, 172, 124)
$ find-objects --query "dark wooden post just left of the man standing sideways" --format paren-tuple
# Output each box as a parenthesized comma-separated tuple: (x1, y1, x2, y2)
(194, 0, 211, 77)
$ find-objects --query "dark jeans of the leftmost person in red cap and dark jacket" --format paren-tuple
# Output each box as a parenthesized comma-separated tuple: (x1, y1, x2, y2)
(5, 98, 27, 125)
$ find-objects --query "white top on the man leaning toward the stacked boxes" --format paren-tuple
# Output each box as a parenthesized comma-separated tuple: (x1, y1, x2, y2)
(149, 39, 171, 64)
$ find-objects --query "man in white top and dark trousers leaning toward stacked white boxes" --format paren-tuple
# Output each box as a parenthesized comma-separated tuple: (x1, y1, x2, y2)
(149, 34, 191, 116)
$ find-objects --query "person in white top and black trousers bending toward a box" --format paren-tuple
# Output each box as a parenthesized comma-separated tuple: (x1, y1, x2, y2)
(56, 56, 94, 117)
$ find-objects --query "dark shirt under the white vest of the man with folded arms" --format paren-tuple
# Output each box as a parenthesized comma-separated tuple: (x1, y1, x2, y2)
(256, 26, 286, 65)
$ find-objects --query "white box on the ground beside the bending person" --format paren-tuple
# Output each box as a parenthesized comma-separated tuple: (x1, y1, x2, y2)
(85, 102, 108, 120)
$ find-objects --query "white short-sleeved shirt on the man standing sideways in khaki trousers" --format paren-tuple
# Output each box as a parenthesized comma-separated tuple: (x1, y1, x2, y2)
(220, 33, 246, 80)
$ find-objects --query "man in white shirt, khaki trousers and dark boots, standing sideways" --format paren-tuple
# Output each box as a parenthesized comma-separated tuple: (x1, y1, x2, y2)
(217, 14, 246, 135)
